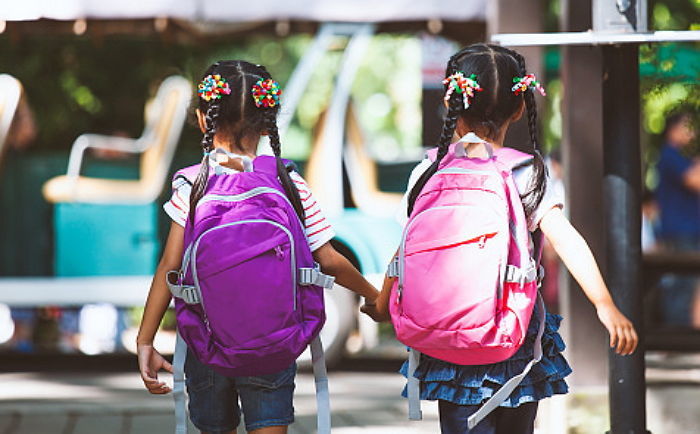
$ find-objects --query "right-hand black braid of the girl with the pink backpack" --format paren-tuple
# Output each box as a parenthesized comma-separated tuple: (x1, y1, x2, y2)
(508, 50, 547, 216)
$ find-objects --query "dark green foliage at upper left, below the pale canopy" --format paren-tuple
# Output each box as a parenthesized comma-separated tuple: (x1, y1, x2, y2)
(0, 35, 309, 154)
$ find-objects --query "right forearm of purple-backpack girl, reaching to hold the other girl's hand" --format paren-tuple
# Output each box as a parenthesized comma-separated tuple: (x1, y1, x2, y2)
(313, 243, 379, 303)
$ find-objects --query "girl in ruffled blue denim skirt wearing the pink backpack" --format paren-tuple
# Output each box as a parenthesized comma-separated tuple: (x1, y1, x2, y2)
(363, 44, 638, 434)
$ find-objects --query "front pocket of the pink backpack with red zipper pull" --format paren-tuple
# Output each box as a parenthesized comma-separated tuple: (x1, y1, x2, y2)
(399, 205, 508, 330)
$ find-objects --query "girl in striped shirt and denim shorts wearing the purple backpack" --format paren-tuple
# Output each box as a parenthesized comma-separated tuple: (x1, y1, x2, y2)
(137, 60, 378, 434)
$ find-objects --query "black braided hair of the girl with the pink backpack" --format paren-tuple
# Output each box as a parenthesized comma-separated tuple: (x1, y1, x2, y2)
(408, 44, 547, 216)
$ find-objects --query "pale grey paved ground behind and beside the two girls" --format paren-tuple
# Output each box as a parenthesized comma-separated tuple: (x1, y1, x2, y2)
(0, 352, 700, 434)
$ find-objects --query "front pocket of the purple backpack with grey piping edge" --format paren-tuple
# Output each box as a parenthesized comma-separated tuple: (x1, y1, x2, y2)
(192, 219, 298, 349)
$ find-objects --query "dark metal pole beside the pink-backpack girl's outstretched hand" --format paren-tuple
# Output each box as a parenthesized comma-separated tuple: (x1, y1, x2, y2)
(603, 44, 647, 434)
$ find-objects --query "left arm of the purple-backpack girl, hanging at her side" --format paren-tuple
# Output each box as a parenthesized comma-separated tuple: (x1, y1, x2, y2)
(136, 222, 184, 395)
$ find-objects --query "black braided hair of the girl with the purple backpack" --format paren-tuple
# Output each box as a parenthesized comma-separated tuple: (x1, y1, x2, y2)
(190, 60, 304, 220)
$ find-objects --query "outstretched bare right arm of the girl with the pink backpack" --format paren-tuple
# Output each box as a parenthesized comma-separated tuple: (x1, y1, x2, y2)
(540, 207, 639, 355)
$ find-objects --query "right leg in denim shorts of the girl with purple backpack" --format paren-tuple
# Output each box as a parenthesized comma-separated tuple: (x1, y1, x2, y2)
(236, 363, 297, 434)
